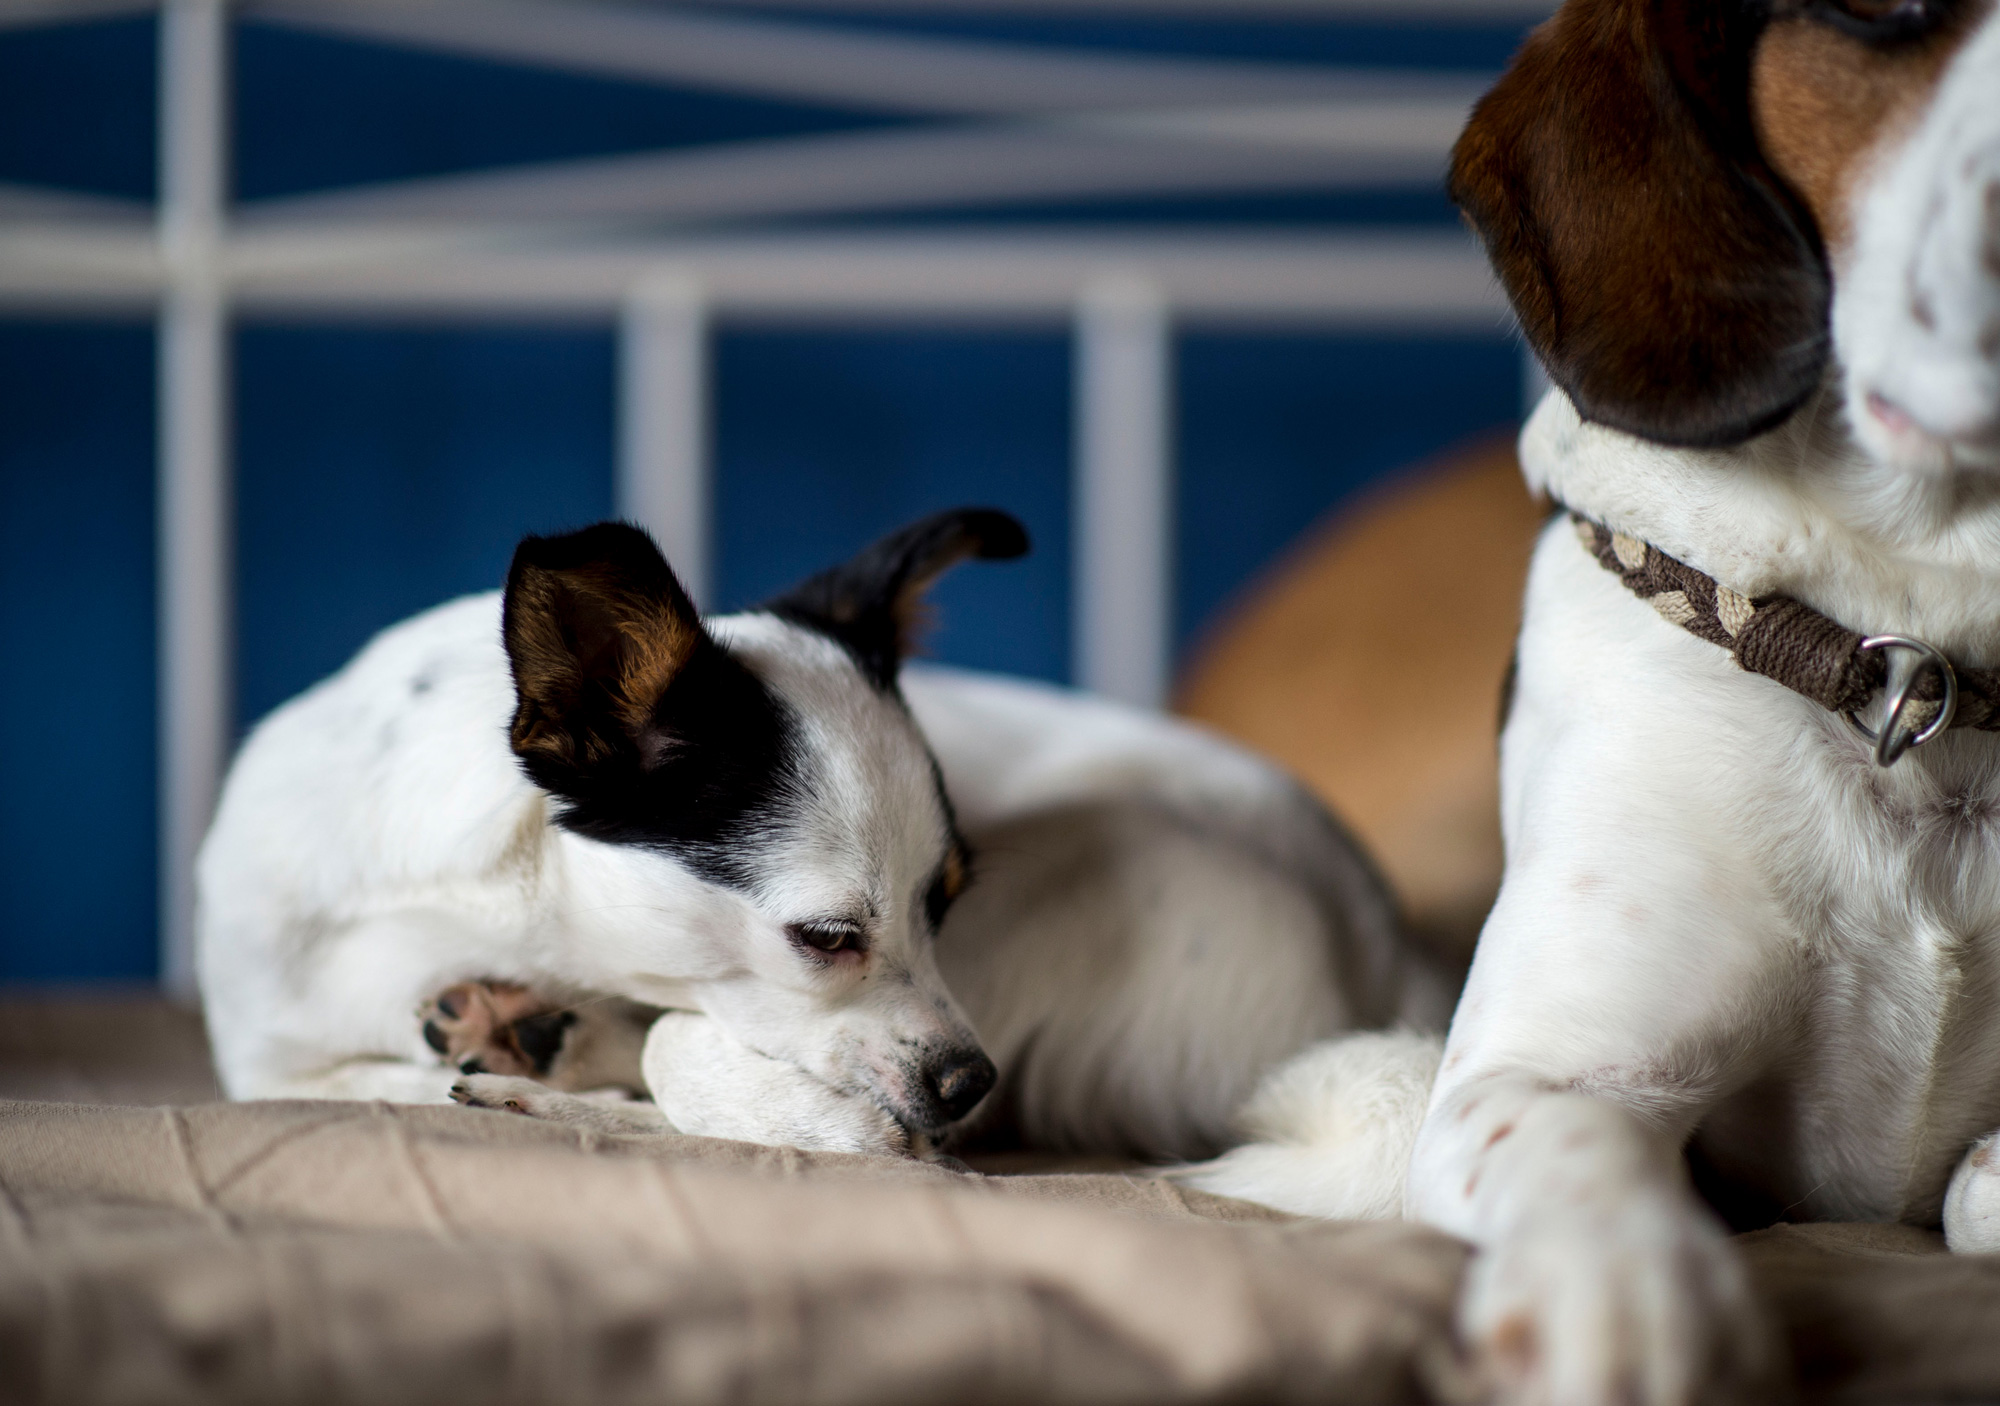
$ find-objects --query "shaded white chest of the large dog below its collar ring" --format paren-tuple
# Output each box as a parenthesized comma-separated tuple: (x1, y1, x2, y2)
(1772, 734, 2000, 1222)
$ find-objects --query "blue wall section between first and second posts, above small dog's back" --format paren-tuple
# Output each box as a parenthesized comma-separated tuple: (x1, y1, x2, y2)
(236, 326, 612, 728)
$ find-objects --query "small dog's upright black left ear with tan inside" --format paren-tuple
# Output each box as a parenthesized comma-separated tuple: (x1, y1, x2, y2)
(500, 522, 706, 796)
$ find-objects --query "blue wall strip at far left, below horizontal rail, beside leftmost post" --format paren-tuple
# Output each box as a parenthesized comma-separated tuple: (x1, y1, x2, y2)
(0, 322, 156, 980)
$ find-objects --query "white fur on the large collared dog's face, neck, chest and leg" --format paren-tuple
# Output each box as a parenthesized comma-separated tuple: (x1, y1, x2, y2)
(1230, 16, 2000, 1406)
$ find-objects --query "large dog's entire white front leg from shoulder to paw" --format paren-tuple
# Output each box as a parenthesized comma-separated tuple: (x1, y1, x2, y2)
(1408, 526, 1812, 1406)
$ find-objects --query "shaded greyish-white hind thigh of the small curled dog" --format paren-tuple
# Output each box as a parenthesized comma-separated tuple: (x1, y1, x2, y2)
(938, 800, 1386, 1162)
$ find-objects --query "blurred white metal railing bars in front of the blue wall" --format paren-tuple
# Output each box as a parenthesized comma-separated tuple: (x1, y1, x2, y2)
(0, 0, 1548, 994)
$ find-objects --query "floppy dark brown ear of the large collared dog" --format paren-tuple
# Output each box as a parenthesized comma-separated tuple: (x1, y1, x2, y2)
(1452, 0, 1830, 446)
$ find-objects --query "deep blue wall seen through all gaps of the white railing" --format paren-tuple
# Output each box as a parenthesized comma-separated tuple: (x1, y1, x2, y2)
(0, 12, 1518, 984)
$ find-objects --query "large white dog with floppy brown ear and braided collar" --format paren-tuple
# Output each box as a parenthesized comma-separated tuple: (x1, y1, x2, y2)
(1194, 0, 2000, 1406)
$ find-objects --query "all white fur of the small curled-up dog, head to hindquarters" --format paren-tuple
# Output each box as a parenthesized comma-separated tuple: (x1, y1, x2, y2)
(184, 596, 1408, 1156)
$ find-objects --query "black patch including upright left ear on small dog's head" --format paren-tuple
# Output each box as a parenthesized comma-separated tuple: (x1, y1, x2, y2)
(502, 522, 798, 884)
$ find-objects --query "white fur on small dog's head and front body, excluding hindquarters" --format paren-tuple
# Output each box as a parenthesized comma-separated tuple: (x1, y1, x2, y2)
(198, 596, 972, 1136)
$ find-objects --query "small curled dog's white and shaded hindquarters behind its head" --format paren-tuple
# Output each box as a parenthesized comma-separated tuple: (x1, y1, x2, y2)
(906, 668, 1448, 1158)
